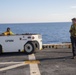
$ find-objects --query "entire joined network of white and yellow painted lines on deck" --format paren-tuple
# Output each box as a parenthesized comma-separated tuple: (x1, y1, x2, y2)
(0, 54, 41, 75)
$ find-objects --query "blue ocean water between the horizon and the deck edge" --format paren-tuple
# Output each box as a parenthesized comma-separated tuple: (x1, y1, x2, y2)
(0, 22, 71, 44)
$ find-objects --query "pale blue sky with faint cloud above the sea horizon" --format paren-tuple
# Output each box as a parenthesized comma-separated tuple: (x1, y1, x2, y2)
(0, 0, 76, 23)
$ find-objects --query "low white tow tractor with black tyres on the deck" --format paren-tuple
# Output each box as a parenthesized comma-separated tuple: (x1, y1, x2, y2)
(0, 34, 42, 54)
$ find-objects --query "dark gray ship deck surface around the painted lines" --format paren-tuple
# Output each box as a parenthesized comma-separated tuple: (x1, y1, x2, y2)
(0, 49, 76, 75)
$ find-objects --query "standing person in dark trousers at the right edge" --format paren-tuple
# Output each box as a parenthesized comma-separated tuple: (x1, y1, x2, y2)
(69, 18, 76, 59)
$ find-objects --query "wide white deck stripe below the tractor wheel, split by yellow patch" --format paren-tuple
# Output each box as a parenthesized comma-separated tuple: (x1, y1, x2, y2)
(29, 54, 41, 75)
